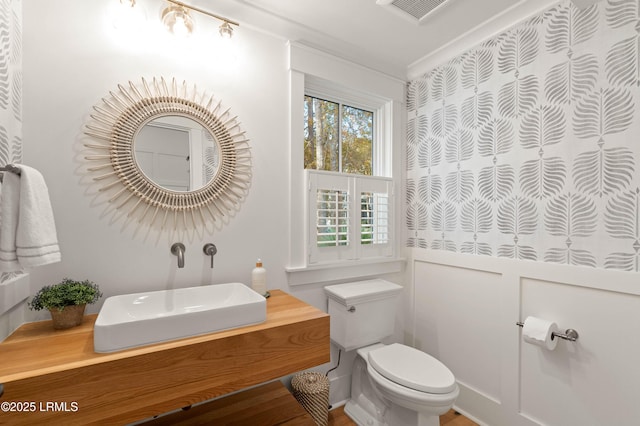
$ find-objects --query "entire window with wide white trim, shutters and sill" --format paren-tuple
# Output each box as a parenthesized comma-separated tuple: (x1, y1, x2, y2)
(286, 42, 405, 286)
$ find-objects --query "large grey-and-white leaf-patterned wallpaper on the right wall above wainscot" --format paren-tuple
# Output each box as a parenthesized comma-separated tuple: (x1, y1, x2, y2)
(405, 0, 640, 272)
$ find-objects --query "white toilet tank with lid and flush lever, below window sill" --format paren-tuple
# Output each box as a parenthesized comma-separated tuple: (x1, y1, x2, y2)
(324, 279, 402, 351)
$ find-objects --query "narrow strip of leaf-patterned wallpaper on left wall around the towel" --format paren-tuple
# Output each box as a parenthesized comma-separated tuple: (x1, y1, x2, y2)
(0, 0, 22, 283)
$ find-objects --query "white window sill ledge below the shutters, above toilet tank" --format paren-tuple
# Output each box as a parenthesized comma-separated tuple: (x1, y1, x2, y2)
(285, 258, 406, 286)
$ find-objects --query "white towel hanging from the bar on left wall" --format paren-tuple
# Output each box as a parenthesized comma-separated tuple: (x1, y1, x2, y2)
(0, 165, 61, 270)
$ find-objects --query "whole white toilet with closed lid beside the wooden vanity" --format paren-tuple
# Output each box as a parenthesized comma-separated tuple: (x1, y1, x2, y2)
(324, 279, 459, 426)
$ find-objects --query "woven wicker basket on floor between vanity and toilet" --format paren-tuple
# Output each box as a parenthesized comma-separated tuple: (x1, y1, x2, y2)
(291, 372, 329, 426)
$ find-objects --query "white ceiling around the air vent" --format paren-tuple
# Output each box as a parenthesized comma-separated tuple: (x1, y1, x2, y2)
(198, 0, 558, 80)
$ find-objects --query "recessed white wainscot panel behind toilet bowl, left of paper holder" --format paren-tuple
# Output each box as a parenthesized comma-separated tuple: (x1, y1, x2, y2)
(414, 261, 505, 412)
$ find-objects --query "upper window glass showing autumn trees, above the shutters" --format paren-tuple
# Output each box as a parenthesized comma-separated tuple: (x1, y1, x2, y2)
(304, 95, 374, 176)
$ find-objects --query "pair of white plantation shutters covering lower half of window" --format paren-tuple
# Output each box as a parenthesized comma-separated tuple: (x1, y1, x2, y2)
(305, 170, 393, 264)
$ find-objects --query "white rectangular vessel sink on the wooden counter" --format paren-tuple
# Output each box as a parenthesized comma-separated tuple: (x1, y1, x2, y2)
(93, 283, 267, 352)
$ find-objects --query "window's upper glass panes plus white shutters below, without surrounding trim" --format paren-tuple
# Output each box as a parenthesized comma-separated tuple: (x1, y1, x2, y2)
(304, 89, 391, 264)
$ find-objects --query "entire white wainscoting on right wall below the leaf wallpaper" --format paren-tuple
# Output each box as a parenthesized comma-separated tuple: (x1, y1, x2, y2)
(411, 249, 640, 426)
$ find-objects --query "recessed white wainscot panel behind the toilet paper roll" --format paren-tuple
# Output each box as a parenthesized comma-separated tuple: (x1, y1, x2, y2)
(520, 278, 640, 426)
